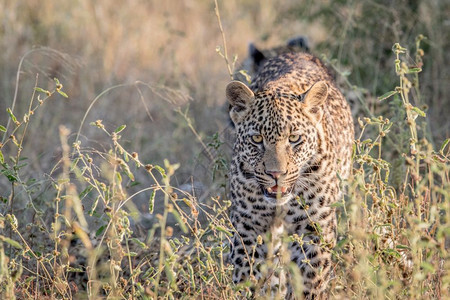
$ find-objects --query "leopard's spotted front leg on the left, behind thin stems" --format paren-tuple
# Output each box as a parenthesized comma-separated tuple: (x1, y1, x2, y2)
(230, 206, 289, 299)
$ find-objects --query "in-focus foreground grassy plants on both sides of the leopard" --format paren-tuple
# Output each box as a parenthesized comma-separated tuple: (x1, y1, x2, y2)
(0, 37, 450, 299)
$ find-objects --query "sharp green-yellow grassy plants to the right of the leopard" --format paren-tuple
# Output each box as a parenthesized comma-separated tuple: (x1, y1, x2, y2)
(328, 36, 450, 299)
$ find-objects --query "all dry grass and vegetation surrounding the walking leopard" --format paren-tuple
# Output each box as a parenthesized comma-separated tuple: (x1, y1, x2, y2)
(0, 0, 450, 299)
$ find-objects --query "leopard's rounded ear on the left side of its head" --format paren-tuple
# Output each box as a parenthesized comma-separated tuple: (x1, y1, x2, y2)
(226, 81, 255, 125)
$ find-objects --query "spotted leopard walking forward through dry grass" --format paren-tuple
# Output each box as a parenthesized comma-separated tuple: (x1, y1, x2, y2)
(225, 43, 354, 299)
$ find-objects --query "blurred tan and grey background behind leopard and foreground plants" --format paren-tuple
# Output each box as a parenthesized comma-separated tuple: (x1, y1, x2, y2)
(0, 0, 450, 209)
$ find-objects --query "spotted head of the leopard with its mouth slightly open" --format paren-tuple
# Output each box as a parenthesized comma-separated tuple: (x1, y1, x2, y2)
(226, 81, 328, 205)
